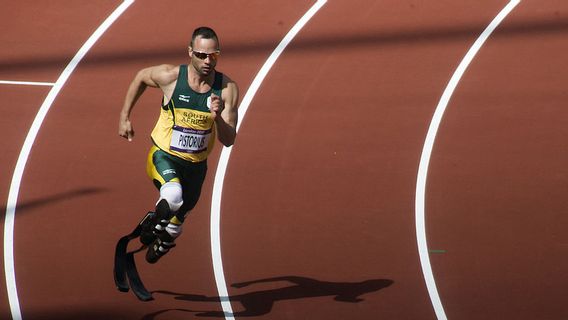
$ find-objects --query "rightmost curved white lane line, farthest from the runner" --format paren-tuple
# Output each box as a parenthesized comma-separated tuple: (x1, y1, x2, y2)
(415, 0, 521, 320)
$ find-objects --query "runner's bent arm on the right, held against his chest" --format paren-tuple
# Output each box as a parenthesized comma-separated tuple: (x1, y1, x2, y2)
(212, 76, 239, 147)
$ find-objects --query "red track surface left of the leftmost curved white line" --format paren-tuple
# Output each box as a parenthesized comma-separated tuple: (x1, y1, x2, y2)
(0, 1, 127, 319)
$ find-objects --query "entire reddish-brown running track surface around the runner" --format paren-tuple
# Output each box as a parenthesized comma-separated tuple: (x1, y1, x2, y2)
(0, 0, 568, 319)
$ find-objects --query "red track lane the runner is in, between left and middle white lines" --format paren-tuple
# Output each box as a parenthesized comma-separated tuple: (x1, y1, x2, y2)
(10, 1, 320, 319)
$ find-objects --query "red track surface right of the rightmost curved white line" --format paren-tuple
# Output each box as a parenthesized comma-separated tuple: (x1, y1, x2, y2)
(429, 1, 568, 319)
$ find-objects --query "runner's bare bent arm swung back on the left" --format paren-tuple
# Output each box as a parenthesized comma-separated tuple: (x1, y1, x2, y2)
(118, 64, 179, 141)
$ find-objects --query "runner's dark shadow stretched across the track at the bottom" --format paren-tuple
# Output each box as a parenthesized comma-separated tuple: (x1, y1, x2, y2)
(143, 276, 394, 320)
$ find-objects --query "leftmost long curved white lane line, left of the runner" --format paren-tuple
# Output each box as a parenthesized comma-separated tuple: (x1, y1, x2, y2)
(4, 0, 134, 320)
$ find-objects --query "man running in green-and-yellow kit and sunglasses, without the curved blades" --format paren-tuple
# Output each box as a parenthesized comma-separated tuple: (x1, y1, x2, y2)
(118, 27, 239, 263)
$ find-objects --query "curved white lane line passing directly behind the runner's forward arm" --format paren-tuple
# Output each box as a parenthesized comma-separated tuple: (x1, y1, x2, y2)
(210, 0, 327, 320)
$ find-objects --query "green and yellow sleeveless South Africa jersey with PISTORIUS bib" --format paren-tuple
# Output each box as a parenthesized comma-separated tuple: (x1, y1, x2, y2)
(151, 65, 223, 162)
